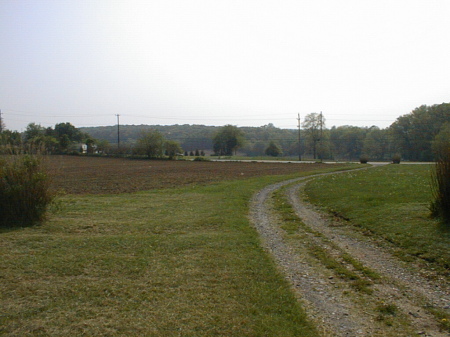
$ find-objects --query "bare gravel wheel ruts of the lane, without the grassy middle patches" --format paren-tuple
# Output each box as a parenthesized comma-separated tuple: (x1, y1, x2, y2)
(250, 172, 450, 336)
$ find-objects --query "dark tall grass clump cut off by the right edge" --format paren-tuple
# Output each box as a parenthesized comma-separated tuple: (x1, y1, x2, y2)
(430, 148, 450, 227)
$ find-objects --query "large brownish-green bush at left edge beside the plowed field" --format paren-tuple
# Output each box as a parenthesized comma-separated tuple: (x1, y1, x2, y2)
(0, 155, 55, 227)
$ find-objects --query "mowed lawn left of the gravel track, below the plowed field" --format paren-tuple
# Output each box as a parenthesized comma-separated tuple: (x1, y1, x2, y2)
(0, 161, 356, 336)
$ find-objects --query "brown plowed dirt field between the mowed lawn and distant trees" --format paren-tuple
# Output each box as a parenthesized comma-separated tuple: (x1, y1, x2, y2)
(44, 156, 329, 194)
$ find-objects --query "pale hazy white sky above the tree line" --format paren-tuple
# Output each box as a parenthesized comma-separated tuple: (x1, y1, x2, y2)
(0, 0, 450, 131)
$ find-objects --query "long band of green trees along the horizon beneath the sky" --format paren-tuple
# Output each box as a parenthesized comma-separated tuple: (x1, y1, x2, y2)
(0, 103, 450, 161)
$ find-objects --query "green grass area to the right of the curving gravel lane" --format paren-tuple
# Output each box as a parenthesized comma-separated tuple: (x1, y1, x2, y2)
(306, 165, 450, 277)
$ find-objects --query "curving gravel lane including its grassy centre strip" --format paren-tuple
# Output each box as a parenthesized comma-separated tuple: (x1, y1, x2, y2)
(250, 173, 450, 336)
